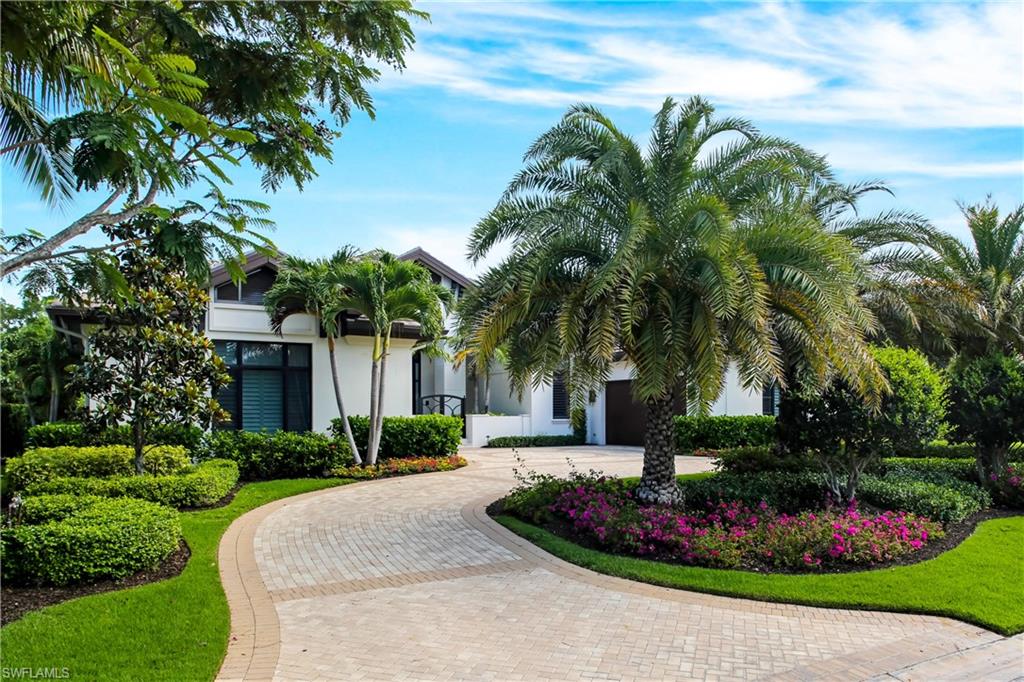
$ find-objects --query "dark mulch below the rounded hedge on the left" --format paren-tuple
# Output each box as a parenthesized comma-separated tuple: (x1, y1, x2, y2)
(0, 540, 191, 625)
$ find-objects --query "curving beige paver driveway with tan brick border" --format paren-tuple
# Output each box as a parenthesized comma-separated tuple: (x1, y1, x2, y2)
(220, 447, 1024, 680)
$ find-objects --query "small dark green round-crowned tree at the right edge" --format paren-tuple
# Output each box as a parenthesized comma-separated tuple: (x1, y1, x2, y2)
(949, 353, 1024, 483)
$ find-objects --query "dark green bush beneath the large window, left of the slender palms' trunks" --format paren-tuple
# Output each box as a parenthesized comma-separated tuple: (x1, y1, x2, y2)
(201, 431, 352, 480)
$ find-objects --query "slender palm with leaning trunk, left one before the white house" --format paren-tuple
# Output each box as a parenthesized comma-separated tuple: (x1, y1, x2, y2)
(263, 247, 362, 464)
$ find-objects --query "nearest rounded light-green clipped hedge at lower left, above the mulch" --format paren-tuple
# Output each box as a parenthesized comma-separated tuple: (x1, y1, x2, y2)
(0, 495, 181, 586)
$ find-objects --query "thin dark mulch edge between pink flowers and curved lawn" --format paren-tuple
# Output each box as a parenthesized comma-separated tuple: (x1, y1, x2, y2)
(486, 493, 1021, 576)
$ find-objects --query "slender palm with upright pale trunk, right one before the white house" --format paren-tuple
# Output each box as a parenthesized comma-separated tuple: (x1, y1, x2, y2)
(334, 251, 452, 466)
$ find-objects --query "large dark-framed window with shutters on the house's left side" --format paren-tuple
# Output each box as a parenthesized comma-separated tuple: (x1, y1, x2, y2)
(214, 341, 312, 431)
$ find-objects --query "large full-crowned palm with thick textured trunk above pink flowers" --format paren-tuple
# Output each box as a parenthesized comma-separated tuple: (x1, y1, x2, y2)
(461, 97, 884, 503)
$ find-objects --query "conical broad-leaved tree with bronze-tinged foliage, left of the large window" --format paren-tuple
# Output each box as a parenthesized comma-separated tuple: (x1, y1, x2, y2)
(73, 216, 230, 473)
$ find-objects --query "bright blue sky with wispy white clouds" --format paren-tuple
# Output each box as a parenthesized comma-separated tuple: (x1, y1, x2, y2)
(0, 0, 1024, 298)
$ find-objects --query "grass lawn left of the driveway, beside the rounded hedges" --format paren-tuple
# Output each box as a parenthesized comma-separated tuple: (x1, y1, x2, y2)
(0, 478, 351, 680)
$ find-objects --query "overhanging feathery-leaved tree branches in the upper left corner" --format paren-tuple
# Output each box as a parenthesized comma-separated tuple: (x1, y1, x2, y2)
(0, 0, 426, 276)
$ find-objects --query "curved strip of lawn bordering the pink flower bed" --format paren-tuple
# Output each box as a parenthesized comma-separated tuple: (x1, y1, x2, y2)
(497, 516, 1024, 635)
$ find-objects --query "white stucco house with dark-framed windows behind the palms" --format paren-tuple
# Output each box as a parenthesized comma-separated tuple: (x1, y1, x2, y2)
(49, 248, 774, 445)
